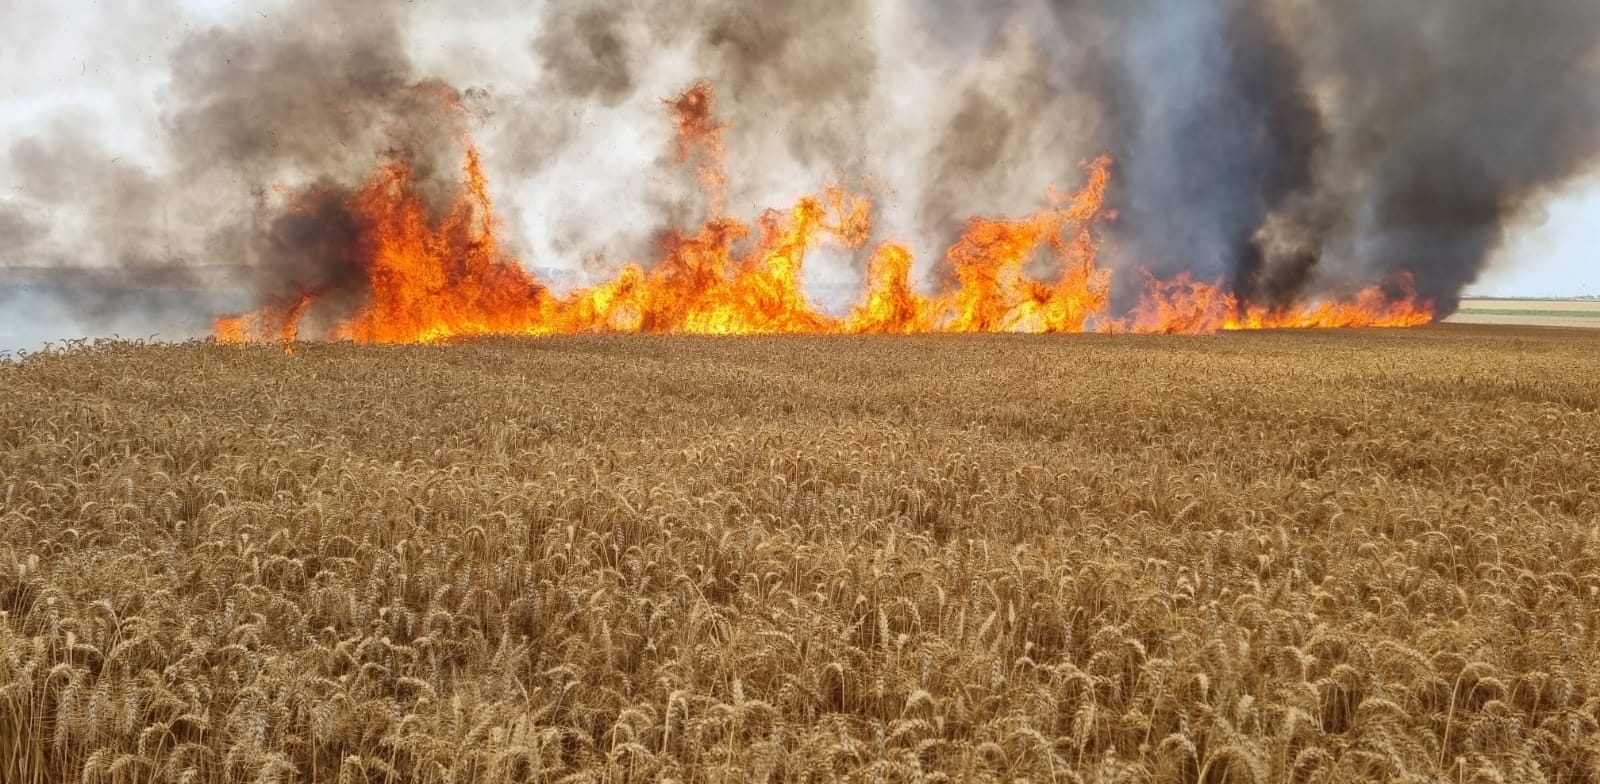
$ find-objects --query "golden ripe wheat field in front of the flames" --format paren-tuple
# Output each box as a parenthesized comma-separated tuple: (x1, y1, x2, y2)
(0, 325, 1600, 784)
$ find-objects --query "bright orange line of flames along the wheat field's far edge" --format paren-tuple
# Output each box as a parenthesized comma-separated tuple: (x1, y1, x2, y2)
(216, 83, 1432, 346)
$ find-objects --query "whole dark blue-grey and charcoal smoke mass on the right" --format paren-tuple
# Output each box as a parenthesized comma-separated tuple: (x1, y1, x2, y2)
(1054, 0, 1600, 312)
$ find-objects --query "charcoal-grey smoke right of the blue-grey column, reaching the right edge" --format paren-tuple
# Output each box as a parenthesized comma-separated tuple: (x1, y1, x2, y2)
(1260, 0, 1600, 307)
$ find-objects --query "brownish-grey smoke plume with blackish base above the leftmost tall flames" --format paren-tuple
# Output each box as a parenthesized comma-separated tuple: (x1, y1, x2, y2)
(163, 0, 480, 316)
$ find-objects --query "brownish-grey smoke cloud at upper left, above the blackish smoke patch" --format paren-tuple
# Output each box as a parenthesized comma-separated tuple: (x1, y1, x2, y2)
(163, 0, 486, 216)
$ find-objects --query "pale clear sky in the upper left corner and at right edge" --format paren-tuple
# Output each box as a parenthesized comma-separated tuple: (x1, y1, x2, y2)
(0, 0, 1600, 296)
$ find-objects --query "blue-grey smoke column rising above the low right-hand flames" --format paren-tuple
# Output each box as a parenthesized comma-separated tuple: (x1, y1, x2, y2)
(1101, 0, 1320, 305)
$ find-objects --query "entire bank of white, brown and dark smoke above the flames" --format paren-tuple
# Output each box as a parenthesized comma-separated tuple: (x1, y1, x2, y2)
(0, 0, 1600, 328)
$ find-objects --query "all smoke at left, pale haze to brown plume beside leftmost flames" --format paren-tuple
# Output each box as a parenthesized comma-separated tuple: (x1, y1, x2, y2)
(0, 0, 467, 323)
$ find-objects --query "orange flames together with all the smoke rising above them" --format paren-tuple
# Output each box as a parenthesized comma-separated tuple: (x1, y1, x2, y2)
(0, 0, 1600, 342)
